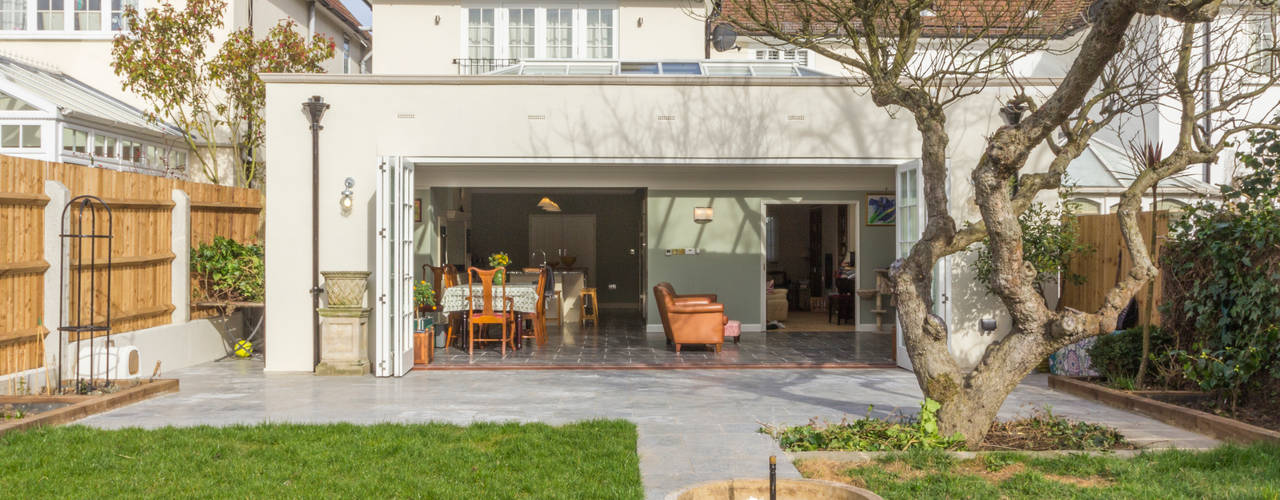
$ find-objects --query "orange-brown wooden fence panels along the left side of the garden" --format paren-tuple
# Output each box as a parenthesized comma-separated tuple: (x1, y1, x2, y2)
(0, 155, 262, 375)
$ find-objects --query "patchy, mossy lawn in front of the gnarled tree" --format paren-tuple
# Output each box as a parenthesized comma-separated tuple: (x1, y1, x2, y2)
(796, 444, 1280, 499)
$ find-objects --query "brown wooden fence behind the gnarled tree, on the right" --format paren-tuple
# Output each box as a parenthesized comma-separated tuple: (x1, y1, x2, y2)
(1061, 211, 1169, 325)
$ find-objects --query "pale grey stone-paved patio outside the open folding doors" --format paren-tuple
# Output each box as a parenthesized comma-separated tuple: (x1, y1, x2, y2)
(81, 361, 1217, 499)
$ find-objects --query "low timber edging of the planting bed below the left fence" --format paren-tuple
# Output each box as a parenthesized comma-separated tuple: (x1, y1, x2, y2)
(0, 379, 178, 436)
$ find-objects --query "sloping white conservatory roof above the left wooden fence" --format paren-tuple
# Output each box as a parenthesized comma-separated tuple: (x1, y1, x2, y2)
(0, 56, 182, 136)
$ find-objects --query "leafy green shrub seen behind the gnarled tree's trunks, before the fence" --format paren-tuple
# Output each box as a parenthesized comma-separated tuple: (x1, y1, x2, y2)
(970, 189, 1093, 294)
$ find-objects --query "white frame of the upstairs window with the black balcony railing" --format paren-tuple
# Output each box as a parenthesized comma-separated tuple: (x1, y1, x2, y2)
(458, 0, 622, 60)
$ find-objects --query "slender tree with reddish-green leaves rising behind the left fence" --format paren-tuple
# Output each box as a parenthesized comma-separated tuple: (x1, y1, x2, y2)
(111, 0, 334, 187)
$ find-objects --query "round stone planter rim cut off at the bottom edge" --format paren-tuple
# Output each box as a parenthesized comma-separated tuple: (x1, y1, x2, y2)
(667, 480, 881, 500)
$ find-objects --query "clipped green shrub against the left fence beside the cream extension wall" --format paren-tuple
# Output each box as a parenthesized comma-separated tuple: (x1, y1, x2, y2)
(191, 237, 266, 302)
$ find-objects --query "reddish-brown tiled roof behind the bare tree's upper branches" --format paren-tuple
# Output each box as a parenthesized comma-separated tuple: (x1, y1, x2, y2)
(721, 0, 1093, 37)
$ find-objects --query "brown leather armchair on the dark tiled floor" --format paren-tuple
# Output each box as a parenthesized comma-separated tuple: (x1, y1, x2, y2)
(653, 281, 728, 353)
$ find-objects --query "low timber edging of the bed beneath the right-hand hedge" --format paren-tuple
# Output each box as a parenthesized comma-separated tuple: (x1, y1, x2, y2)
(1048, 375, 1280, 444)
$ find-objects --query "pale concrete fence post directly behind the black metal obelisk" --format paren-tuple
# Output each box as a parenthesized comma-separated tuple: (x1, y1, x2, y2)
(40, 180, 72, 384)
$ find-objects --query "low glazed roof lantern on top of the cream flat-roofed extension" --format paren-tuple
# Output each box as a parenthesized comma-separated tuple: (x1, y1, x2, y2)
(485, 59, 831, 77)
